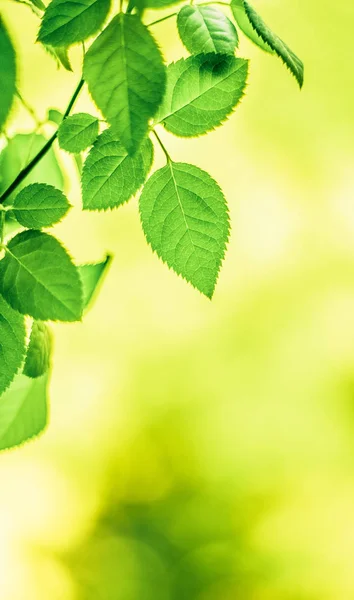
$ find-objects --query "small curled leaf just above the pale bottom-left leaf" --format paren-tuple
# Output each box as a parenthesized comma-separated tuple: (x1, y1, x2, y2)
(23, 321, 53, 379)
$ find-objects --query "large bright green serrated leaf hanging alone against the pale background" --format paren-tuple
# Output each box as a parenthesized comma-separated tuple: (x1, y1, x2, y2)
(140, 161, 229, 298)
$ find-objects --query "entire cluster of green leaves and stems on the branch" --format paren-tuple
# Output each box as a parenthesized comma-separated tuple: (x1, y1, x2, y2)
(0, 0, 303, 449)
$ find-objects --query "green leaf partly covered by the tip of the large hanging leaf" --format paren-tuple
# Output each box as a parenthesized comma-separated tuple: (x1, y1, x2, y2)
(82, 129, 153, 210)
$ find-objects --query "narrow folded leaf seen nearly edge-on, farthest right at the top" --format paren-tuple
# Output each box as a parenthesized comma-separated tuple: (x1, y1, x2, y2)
(235, 0, 304, 88)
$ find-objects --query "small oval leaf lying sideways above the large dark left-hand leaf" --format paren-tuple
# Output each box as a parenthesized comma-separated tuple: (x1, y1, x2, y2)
(13, 183, 70, 229)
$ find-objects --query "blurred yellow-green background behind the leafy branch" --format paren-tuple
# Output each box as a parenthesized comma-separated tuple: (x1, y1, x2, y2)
(0, 0, 354, 600)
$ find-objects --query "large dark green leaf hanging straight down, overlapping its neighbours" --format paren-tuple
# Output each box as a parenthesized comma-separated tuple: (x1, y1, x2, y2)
(84, 14, 165, 154)
